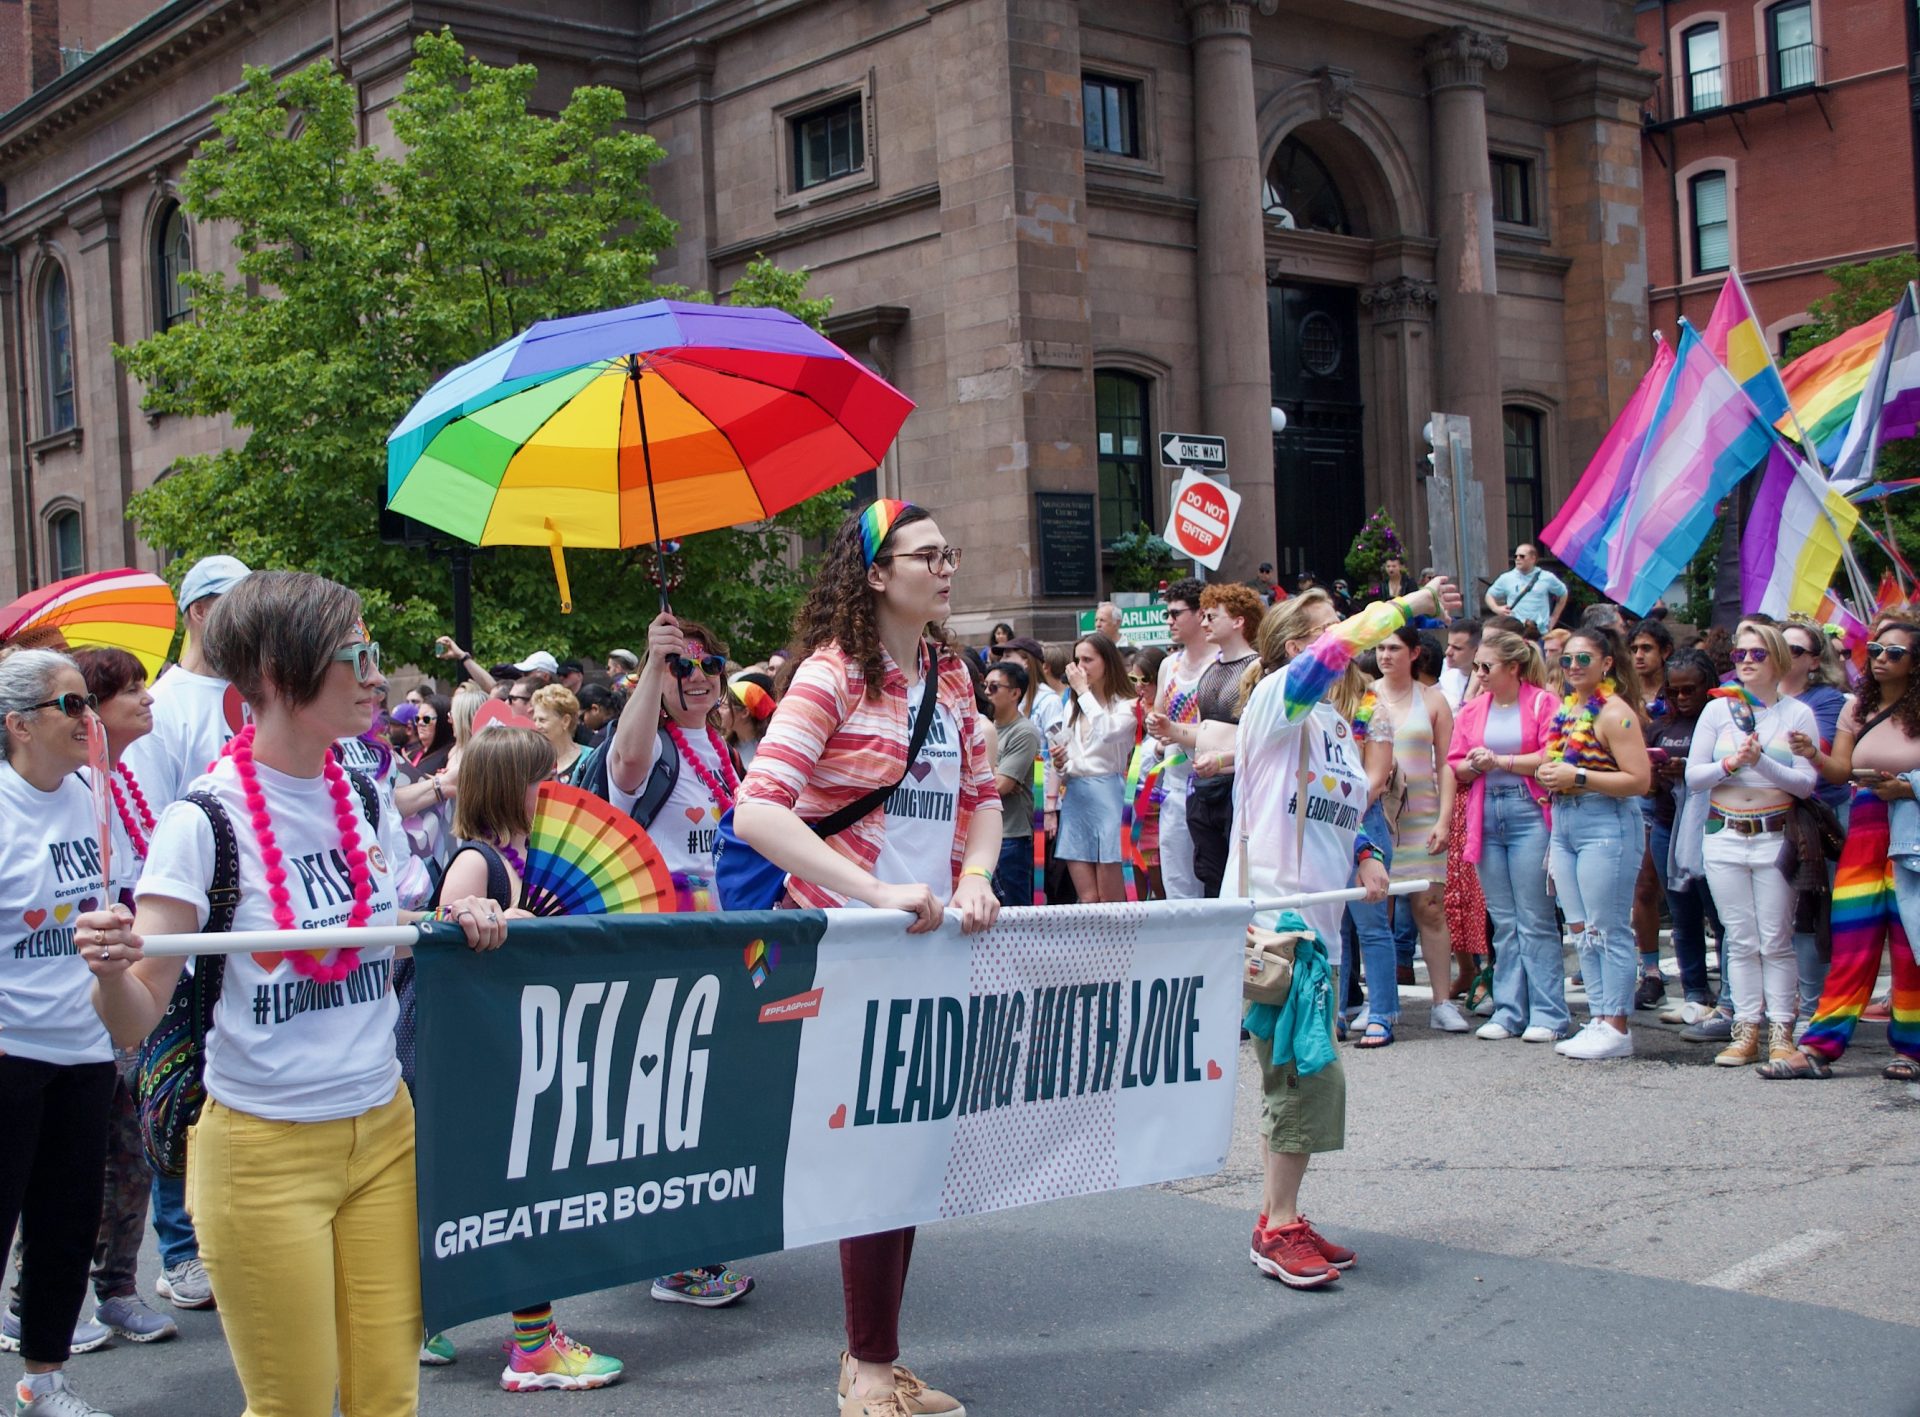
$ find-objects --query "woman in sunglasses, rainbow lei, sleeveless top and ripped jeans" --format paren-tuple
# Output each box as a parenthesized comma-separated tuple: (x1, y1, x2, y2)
(1534, 626, 1653, 1060)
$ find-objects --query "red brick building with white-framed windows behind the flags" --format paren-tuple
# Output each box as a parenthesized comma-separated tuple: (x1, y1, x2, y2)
(1636, 0, 1920, 355)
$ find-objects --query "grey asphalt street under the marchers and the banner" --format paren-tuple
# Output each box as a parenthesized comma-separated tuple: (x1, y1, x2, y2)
(18, 960, 1920, 1417)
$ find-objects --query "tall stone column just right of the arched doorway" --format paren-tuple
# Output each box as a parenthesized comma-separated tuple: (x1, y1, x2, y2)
(1423, 25, 1507, 556)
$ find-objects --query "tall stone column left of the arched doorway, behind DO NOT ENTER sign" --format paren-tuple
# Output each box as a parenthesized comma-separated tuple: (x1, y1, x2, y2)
(1185, 0, 1275, 580)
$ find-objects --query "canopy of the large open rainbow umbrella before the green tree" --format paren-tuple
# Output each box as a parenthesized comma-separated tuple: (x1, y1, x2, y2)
(386, 300, 914, 609)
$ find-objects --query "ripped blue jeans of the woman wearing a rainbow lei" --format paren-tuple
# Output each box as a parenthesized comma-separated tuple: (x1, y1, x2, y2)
(1548, 793, 1647, 1018)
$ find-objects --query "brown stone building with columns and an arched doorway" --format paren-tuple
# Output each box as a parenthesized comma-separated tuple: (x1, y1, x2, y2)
(0, 0, 1651, 632)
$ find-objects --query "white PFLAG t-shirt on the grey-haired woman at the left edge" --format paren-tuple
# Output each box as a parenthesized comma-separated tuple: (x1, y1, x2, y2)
(0, 760, 113, 1059)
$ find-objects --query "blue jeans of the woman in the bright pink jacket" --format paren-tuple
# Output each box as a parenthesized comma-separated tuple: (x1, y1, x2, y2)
(1478, 787, 1572, 1033)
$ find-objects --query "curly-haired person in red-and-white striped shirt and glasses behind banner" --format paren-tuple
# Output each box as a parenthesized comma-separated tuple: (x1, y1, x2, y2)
(733, 501, 1000, 1417)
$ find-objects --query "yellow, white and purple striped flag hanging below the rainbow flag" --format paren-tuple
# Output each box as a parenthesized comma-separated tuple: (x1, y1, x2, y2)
(1740, 442, 1860, 618)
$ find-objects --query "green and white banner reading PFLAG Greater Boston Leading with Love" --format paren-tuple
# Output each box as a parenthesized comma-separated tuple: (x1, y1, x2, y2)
(415, 901, 1252, 1331)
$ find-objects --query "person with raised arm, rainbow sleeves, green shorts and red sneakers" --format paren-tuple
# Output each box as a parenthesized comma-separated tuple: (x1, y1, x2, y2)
(1215, 576, 1459, 1288)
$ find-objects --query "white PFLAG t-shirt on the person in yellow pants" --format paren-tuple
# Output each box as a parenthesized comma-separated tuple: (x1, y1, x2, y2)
(134, 758, 407, 1121)
